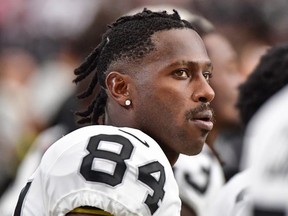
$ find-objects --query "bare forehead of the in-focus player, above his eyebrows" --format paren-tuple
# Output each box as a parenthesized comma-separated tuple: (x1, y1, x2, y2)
(152, 28, 210, 62)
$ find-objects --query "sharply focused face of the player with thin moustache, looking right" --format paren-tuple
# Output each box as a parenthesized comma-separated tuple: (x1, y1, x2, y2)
(132, 29, 214, 159)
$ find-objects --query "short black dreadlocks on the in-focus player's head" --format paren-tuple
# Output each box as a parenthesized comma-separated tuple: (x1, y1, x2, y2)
(74, 9, 194, 124)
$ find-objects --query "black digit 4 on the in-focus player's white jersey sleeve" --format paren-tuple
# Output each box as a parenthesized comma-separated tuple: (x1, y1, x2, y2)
(138, 161, 166, 215)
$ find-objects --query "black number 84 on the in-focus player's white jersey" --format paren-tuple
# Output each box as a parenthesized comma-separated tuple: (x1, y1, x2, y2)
(80, 134, 166, 214)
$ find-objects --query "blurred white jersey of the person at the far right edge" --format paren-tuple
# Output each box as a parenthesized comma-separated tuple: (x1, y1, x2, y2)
(237, 83, 288, 216)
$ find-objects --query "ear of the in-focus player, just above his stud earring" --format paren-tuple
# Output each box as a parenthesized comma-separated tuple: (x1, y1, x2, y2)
(105, 71, 131, 106)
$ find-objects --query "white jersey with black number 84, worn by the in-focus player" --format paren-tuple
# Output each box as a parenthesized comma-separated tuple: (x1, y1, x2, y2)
(14, 125, 181, 216)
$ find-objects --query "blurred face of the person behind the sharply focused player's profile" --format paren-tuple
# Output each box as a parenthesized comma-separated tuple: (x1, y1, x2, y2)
(203, 33, 243, 128)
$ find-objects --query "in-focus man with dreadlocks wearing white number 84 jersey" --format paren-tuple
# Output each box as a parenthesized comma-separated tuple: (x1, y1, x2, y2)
(15, 10, 214, 216)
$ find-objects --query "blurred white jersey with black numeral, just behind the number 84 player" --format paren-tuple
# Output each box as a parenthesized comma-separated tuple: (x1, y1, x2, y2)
(173, 144, 225, 216)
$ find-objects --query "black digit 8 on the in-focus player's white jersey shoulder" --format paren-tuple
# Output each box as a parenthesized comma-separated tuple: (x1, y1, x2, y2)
(80, 134, 133, 186)
